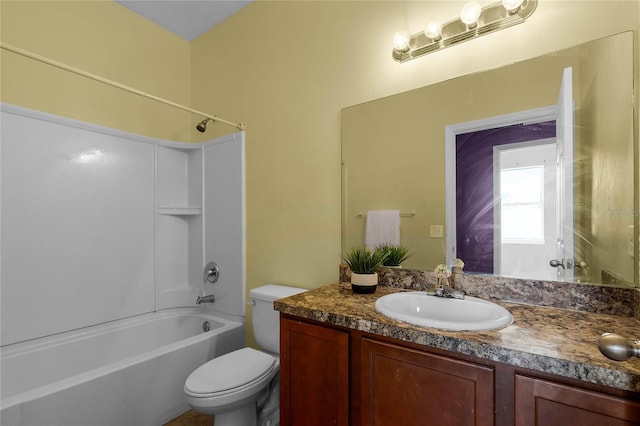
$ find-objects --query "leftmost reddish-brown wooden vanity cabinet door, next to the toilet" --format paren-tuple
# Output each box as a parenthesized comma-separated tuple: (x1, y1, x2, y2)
(280, 318, 349, 426)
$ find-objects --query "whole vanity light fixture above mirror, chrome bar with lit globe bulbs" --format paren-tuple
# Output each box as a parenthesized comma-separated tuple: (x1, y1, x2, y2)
(392, 0, 538, 62)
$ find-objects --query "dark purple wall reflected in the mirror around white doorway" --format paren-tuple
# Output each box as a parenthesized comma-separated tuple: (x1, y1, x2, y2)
(456, 121, 556, 274)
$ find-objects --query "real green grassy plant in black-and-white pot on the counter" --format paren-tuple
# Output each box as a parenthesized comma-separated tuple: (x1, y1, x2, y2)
(342, 247, 387, 294)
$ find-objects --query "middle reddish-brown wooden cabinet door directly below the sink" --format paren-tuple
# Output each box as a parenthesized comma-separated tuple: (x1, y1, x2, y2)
(360, 338, 495, 426)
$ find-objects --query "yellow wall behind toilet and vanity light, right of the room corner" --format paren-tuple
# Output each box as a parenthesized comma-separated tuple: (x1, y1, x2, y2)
(192, 0, 639, 342)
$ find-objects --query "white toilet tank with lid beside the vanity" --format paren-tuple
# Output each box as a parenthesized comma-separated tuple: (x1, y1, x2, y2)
(249, 284, 307, 354)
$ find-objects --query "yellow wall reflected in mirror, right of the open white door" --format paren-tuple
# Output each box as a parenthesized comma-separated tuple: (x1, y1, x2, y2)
(574, 35, 638, 284)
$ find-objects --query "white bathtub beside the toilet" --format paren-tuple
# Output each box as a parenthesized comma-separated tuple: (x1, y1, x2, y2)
(0, 307, 244, 426)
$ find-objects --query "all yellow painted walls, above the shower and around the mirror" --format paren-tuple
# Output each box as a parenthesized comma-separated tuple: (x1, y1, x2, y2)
(0, 0, 640, 348)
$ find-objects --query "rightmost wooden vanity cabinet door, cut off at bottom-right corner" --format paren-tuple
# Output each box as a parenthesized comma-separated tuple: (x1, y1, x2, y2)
(515, 375, 640, 426)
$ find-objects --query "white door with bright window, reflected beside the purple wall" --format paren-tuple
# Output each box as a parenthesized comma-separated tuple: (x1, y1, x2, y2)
(493, 138, 558, 280)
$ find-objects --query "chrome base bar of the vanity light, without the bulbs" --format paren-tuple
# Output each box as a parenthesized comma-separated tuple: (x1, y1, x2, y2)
(392, 0, 538, 63)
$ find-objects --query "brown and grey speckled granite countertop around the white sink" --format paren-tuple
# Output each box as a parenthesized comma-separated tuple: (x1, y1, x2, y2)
(275, 283, 640, 392)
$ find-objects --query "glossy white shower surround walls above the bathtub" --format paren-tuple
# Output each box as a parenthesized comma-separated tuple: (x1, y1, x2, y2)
(0, 104, 245, 424)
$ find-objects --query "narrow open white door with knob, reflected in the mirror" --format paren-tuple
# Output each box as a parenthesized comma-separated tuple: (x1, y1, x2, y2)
(549, 68, 574, 281)
